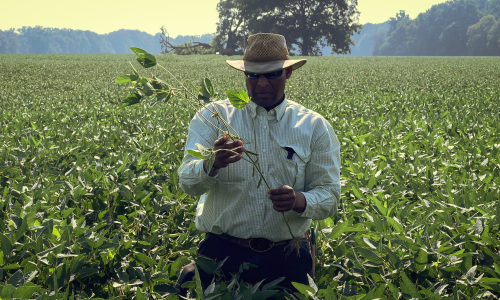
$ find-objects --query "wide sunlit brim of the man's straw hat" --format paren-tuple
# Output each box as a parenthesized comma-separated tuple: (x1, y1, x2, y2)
(226, 59, 307, 74)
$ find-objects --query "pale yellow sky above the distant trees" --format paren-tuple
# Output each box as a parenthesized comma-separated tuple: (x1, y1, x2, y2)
(0, 0, 446, 37)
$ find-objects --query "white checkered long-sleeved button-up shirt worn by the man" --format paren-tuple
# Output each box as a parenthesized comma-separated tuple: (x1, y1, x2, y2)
(178, 98, 340, 242)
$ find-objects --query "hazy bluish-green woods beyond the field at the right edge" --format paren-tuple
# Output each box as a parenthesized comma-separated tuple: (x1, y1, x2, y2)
(373, 0, 500, 56)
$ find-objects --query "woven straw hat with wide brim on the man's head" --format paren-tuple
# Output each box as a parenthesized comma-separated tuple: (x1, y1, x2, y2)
(226, 33, 307, 74)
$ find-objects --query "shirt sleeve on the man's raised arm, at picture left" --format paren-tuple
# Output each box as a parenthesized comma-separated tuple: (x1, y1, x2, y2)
(178, 109, 218, 196)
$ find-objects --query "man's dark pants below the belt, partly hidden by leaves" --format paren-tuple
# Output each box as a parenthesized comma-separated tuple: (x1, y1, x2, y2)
(179, 233, 313, 291)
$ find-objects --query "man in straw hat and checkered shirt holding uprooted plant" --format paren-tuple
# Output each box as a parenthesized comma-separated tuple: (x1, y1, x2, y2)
(178, 33, 340, 289)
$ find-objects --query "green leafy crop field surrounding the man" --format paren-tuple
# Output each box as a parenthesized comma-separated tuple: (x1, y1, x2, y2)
(0, 55, 500, 299)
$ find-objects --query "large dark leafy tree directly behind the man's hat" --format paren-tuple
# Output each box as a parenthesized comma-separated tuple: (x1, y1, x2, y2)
(216, 0, 361, 55)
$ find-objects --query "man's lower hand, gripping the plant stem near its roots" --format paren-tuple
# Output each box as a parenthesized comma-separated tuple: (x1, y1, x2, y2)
(267, 185, 307, 213)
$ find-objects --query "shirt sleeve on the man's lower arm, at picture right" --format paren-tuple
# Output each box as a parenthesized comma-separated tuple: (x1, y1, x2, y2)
(299, 121, 341, 220)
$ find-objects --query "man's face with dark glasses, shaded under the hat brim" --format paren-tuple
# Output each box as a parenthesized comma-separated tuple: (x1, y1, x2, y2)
(246, 67, 293, 109)
